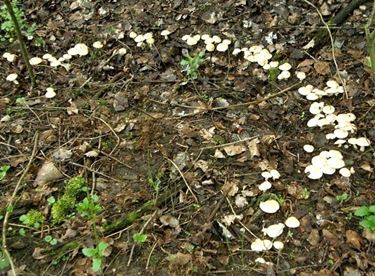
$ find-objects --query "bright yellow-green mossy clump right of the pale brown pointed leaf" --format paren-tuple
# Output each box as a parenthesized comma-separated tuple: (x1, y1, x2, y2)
(50, 176, 87, 224)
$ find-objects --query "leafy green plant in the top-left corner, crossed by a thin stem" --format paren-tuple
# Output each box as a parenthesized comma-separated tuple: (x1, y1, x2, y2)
(0, 0, 36, 42)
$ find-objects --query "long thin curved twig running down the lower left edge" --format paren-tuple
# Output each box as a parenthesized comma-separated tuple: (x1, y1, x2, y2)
(2, 132, 39, 276)
